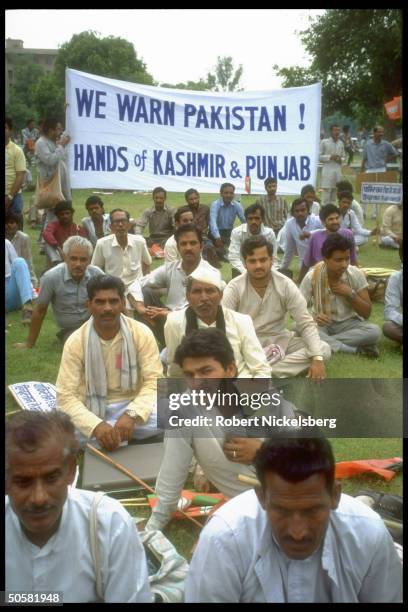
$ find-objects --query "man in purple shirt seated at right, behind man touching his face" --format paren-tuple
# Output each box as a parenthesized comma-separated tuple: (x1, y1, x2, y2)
(298, 204, 357, 284)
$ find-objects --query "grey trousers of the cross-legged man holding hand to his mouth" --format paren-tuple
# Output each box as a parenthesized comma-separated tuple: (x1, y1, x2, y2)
(318, 317, 381, 353)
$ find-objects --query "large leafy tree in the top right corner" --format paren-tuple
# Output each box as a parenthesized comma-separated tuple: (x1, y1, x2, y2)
(274, 9, 402, 136)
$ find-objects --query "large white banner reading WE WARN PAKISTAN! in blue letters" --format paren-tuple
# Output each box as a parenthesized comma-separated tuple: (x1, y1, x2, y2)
(66, 68, 321, 194)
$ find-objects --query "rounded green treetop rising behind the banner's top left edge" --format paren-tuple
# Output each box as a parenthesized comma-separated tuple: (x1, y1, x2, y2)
(54, 31, 153, 87)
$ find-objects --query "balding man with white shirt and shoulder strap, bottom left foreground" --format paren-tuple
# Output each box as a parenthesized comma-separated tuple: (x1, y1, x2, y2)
(5, 410, 152, 604)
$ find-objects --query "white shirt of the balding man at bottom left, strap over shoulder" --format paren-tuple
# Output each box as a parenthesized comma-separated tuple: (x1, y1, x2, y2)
(5, 489, 152, 603)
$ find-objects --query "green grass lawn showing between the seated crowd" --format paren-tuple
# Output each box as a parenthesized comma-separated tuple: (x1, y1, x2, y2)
(5, 179, 402, 558)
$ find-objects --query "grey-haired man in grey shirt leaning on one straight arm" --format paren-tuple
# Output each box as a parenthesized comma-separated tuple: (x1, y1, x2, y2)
(13, 236, 103, 348)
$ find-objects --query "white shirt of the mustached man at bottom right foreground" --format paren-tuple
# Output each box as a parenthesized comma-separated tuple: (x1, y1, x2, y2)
(185, 490, 402, 603)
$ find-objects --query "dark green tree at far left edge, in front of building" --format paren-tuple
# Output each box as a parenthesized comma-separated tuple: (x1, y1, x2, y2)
(6, 55, 44, 131)
